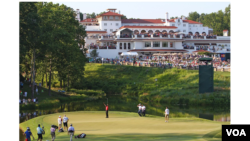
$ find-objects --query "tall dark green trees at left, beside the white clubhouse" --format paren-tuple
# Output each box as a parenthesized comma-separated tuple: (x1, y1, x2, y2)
(18, 1, 86, 96)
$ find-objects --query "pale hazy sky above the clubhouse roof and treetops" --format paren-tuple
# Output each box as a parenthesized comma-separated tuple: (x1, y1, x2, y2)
(52, 1, 231, 19)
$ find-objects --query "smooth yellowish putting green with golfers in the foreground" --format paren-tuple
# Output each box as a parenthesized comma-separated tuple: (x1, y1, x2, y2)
(19, 111, 231, 141)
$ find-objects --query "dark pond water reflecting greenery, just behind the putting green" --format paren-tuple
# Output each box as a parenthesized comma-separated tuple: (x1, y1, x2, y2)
(18, 95, 231, 141)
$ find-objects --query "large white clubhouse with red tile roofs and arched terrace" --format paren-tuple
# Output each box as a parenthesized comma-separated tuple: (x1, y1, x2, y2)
(76, 9, 231, 58)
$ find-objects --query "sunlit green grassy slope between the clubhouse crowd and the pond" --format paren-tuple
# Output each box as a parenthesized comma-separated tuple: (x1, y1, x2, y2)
(22, 63, 231, 105)
